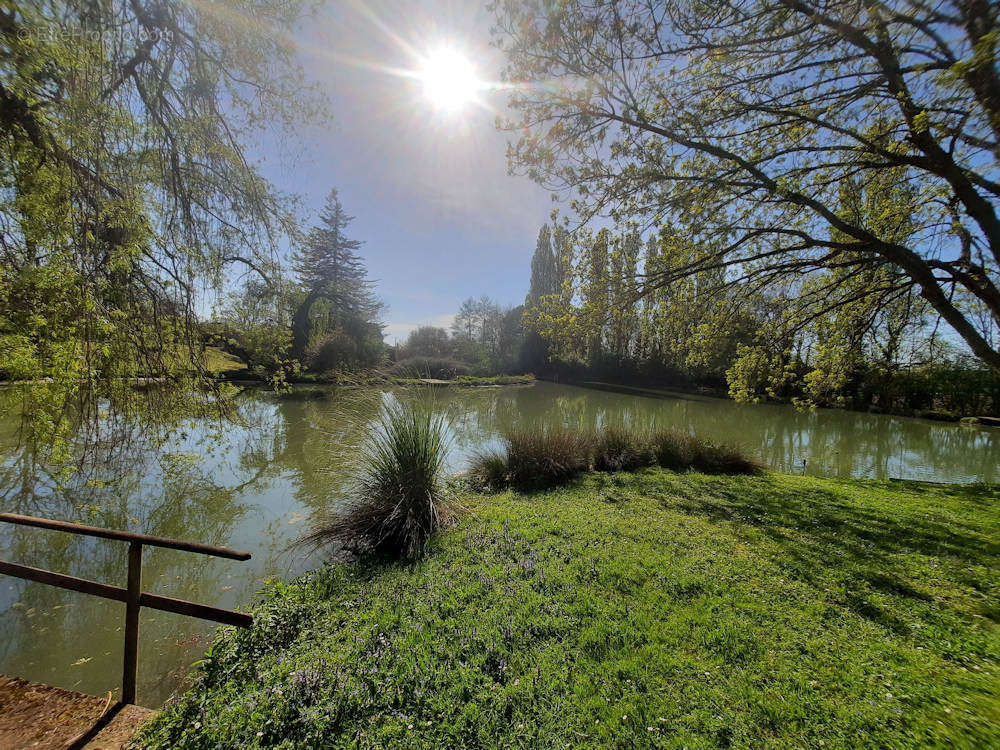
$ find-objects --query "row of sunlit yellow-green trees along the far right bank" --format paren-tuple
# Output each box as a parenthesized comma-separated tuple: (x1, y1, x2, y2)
(521, 217, 1000, 417)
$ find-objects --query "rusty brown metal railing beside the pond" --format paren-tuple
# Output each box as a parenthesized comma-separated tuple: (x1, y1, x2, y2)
(0, 513, 253, 704)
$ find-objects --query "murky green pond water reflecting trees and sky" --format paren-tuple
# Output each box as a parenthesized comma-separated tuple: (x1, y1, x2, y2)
(0, 382, 1000, 706)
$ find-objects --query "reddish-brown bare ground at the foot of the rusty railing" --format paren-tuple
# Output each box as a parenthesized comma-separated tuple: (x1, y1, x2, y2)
(0, 675, 156, 750)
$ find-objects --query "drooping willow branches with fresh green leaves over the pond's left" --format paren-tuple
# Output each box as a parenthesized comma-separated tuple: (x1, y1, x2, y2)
(0, 0, 321, 452)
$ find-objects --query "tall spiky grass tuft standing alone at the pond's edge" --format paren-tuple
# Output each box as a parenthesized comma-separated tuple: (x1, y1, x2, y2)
(301, 404, 447, 560)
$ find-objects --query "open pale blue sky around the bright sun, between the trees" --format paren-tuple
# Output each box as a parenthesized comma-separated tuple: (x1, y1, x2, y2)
(245, 0, 554, 343)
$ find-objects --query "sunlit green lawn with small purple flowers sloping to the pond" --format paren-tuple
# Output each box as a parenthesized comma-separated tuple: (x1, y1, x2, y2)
(137, 468, 1000, 750)
